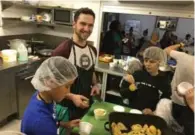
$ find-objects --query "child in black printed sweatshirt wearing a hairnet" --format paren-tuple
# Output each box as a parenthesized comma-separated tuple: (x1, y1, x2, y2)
(120, 47, 171, 110)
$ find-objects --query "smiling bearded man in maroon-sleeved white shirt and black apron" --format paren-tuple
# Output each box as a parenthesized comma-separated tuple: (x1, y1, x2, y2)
(52, 8, 100, 120)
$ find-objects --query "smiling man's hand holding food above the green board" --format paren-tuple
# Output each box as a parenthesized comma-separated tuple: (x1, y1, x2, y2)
(71, 94, 89, 109)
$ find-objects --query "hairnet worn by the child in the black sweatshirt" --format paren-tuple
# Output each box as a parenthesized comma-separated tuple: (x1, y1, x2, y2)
(143, 47, 167, 66)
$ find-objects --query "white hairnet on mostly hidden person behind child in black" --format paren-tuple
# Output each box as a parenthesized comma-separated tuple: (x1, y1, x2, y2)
(127, 58, 143, 74)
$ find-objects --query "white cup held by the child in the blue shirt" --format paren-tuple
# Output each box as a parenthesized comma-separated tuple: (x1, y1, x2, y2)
(79, 122, 93, 135)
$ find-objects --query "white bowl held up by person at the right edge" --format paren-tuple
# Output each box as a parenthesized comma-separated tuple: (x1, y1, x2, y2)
(177, 82, 193, 95)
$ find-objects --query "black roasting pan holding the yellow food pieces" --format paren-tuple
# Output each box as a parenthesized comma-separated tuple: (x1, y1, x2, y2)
(104, 112, 176, 135)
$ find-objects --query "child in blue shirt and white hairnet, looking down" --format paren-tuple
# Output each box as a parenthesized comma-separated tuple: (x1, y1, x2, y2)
(21, 57, 87, 135)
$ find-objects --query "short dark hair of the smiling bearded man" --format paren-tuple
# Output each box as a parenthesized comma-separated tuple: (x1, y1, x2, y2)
(74, 8, 95, 22)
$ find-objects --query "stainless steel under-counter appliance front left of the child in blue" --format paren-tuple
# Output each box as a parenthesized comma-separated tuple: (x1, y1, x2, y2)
(15, 60, 43, 119)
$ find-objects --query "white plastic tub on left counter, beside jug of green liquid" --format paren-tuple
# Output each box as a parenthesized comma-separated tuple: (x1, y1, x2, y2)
(1, 49, 17, 63)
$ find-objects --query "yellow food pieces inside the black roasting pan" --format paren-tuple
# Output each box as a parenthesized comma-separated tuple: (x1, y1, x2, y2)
(111, 122, 162, 135)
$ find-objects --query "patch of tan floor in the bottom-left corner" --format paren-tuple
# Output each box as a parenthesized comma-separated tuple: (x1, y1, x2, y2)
(0, 120, 21, 132)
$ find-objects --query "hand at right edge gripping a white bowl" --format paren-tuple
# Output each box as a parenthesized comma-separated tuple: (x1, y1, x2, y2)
(185, 88, 194, 111)
